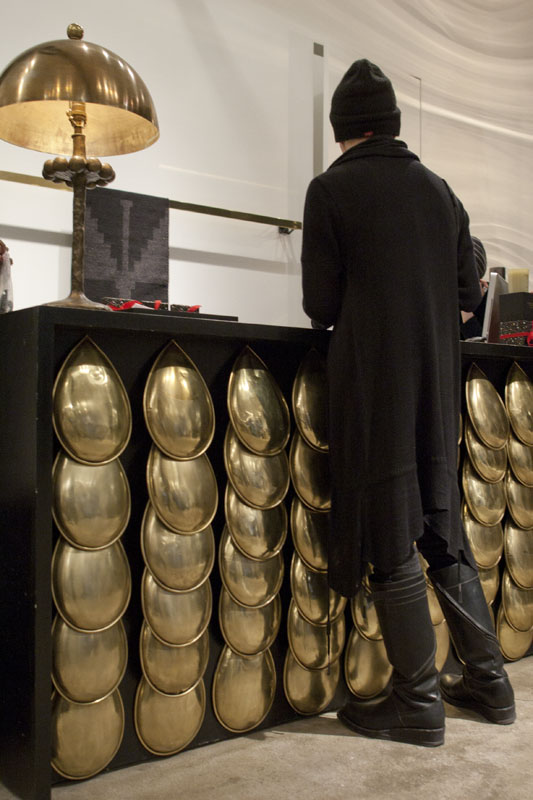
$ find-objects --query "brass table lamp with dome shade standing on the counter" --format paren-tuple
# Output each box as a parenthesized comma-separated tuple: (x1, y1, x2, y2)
(0, 24, 159, 308)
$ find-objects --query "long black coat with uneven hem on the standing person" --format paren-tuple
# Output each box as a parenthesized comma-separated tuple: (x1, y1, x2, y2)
(302, 136, 481, 597)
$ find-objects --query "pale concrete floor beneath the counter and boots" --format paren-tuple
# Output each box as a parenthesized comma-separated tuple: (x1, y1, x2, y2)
(0, 657, 533, 800)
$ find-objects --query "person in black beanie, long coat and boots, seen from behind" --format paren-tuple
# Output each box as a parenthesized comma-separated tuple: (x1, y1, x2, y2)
(302, 59, 515, 746)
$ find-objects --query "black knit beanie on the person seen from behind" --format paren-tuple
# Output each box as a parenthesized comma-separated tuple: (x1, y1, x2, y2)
(329, 58, 400, 142)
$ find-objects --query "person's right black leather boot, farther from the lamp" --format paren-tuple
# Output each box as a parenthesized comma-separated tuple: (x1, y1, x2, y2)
(428, 564, 516, 725)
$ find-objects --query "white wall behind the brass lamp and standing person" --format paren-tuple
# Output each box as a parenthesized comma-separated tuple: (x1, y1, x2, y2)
(0, 0, 533, 326)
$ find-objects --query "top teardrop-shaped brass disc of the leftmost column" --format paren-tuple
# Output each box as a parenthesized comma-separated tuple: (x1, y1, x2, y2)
(52, 336, 131, 464)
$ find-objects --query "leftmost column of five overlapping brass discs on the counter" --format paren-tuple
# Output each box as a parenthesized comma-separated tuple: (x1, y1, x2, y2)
(52, 337, 131, 779)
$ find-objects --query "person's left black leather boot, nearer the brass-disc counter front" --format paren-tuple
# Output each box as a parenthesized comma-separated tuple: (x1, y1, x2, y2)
(337, 553, 444, 747)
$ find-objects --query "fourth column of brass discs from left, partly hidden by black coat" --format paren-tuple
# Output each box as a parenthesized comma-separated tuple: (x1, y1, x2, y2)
(283, 349, 346, 715)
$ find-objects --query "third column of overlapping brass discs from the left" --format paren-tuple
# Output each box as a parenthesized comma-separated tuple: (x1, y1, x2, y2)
(212, 347, 290, 733)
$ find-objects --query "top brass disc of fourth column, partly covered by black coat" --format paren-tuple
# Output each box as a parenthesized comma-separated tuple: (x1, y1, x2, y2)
(292, 347, 328, 451)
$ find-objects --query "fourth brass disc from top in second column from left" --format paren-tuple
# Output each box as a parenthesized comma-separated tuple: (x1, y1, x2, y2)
(141, 569, 213, 644)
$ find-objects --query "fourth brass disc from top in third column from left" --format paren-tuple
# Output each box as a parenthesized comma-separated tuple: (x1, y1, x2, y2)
(218, 525, 285, 608)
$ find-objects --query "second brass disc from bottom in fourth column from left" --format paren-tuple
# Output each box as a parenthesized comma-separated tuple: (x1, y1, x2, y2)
(287, 600, 346, 669)
